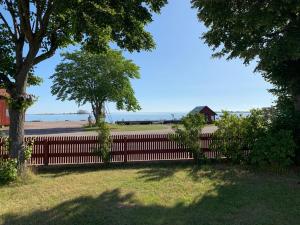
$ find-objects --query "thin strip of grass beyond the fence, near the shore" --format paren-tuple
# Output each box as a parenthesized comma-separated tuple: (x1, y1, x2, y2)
(84, 124, 172, 131)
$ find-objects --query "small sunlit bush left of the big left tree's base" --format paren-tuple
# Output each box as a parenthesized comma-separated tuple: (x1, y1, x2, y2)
(0, 159, 18, 183)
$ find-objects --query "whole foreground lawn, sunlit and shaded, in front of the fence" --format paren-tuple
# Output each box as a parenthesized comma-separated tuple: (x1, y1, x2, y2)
(0, 164, 300, 225)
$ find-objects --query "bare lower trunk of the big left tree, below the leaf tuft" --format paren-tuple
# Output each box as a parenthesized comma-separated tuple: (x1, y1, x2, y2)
(9, 106, 26, 175)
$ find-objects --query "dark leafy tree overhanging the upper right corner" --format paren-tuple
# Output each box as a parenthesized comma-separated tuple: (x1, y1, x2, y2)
(192, 0, 300, 162)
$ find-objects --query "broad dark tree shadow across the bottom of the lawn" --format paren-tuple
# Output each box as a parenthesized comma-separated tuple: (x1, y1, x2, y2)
(3, 174, 300, 225)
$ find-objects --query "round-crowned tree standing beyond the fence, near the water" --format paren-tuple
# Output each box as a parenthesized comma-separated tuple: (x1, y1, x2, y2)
(51, 50, 140, 122)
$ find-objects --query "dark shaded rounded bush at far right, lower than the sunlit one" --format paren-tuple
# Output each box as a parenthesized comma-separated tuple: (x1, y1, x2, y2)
(250, 130, 296, 168)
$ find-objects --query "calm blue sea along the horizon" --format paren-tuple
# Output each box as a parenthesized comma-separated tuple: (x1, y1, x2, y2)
(25, 112, 249, 123)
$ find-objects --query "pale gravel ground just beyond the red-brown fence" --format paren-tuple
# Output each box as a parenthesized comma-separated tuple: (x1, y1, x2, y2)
(3, 121, 216, 136)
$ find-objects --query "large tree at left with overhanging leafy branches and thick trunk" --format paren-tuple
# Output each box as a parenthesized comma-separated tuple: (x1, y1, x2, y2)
(0, 0, 167, 171)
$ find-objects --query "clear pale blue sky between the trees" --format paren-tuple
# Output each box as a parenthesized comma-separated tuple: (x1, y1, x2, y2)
(28, 0, 274, 113)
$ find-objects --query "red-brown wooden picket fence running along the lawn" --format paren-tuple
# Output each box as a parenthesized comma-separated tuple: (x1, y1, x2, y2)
(0, 134, 218, 165)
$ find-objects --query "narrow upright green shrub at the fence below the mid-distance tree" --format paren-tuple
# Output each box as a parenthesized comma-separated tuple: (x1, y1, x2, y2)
(95, 118, 112, 163)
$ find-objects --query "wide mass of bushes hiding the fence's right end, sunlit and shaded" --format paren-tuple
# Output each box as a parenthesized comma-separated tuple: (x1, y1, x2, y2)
(211, 109, 296, 168)
